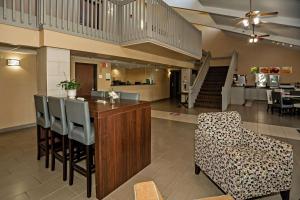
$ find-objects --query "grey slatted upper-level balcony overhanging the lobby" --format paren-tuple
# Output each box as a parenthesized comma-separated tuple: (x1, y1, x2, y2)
(0, 0, 202, 60)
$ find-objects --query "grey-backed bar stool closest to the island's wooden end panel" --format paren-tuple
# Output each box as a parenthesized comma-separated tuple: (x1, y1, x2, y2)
(65, 99, 95, 197)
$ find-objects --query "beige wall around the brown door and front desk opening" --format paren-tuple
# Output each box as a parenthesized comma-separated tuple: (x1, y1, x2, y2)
(71, 56, 170, 101)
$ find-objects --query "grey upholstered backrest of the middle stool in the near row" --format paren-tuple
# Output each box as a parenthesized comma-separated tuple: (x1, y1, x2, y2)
(48, 97, 68, 135)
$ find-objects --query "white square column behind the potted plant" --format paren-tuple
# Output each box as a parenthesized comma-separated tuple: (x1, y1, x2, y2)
(37, 47, 71, 96)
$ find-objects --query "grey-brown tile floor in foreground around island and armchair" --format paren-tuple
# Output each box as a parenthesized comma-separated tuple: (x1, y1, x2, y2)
(0, 118, 300, 200)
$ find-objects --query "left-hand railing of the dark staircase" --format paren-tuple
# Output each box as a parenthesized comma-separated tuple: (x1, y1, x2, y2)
(188, 52, 211, 108)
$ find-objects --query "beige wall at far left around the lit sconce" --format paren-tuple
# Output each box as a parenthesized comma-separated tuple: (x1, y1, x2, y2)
(0, 52, 37, 129)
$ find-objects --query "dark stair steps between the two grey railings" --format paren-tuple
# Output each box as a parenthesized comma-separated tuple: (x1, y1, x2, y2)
(195, 66, 228, 109)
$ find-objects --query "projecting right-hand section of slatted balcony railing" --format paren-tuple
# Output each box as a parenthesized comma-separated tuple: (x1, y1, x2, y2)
(120, 0, 202, 58)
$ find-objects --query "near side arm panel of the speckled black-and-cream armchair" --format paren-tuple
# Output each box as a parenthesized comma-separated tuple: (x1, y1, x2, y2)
(226, 146, 290, 199)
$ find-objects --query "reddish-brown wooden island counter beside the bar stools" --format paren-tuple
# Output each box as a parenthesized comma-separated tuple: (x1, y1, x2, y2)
(87, 97, 151, 199)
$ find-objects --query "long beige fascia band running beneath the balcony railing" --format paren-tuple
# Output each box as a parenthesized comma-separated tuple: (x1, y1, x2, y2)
(0, 24, 194, 68)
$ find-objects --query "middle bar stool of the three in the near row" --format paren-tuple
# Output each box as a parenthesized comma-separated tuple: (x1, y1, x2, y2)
(48, 97, 68, 181)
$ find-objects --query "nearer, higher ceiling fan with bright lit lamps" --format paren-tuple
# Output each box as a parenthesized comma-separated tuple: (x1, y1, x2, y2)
(237, 0, 279, 28)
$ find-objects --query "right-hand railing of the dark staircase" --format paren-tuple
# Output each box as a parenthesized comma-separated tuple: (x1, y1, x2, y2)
(222, 51, 238, 111)
